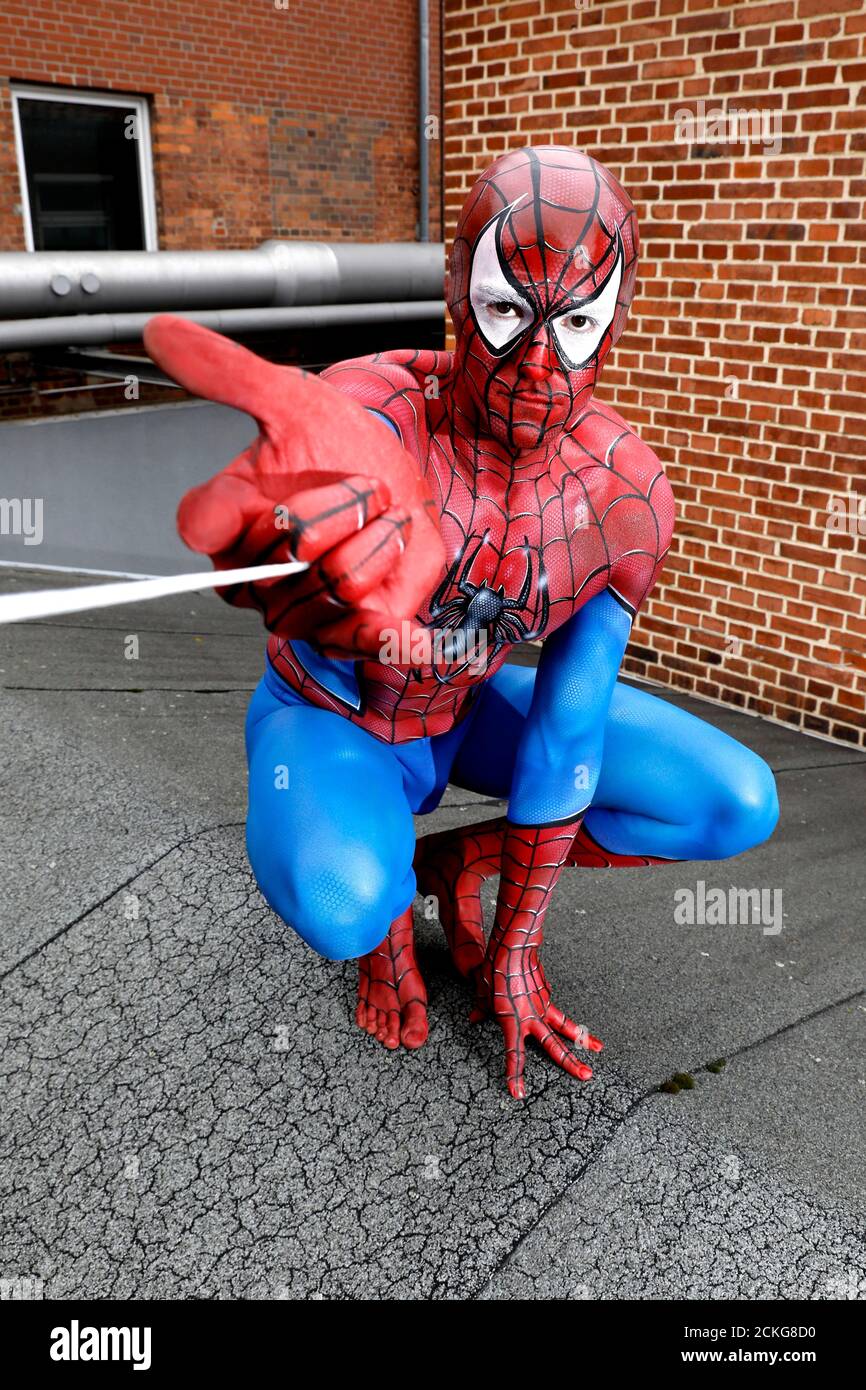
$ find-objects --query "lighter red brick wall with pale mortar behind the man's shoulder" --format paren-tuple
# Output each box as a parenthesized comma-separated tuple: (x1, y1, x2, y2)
(445, 0, 866, 745)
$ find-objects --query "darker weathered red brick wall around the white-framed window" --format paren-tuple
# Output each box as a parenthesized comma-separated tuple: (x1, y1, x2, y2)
(0, 0, 441, 250)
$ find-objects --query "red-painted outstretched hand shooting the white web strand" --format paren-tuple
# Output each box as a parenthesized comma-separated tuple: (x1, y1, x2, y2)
(145, 314, 445, 656)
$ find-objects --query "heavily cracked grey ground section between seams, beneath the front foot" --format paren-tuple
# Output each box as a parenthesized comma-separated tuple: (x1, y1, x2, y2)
(0, 826, 628, 1298)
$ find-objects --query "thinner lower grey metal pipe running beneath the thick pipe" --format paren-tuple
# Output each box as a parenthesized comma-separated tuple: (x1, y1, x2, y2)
(0, 299, 445, 352)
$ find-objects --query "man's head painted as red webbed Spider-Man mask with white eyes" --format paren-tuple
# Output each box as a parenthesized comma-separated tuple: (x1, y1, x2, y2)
(449, 146, 638, 452)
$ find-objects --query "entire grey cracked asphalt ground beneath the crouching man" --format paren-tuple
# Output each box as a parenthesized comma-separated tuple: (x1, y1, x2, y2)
(0, 558, 866, 1300)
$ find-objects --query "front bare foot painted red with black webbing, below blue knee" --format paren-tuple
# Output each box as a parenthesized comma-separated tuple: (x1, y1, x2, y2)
(354, 906, 428, 1048)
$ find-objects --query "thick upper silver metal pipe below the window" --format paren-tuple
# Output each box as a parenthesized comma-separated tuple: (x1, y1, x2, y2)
(0, 240, 445, 322)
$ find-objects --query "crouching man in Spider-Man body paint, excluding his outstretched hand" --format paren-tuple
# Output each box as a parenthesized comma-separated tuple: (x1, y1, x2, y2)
(154, 146, 777, 1095)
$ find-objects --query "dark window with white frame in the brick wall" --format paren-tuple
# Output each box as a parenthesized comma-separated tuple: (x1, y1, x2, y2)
(18, 97, 145, 252)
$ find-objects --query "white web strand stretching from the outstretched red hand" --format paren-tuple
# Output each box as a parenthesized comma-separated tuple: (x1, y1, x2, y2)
(0, 560, 309, 624)
